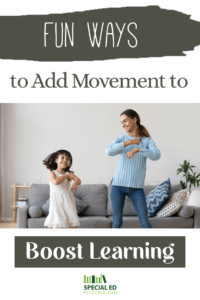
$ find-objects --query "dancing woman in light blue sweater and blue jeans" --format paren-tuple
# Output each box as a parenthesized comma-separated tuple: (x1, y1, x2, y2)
(106, 109, 160, 228)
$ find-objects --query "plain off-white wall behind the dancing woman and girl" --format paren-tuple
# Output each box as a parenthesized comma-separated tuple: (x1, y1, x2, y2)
(2, 104, 200, 219)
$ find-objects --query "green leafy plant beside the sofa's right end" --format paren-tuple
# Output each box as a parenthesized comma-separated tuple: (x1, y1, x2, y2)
(177, 160, 200, 194)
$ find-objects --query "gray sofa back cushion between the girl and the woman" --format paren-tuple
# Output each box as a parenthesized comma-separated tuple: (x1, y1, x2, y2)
(73, 184, 107, 216)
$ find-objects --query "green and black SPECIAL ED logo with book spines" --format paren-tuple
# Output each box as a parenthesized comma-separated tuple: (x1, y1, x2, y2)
(83, 274, 117, 295)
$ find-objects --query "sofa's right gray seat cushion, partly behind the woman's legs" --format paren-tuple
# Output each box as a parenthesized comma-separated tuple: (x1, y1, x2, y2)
(108, 216, 194, 228)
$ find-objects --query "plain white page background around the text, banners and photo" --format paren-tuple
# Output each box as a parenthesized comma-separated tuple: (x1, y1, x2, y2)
(0, 1, 200, 299)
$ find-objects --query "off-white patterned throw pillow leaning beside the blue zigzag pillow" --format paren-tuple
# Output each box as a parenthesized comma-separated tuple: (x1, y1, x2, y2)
(156, 189, 187, 218)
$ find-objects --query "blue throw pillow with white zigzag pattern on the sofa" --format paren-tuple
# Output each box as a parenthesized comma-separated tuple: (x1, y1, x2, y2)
(146, 178, 171, 218)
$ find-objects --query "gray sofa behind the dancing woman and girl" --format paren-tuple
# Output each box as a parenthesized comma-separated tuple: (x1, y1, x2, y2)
(17, 184, 200, 228)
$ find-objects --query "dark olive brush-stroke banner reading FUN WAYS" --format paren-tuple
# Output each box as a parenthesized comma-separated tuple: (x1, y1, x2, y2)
(0, 4, 200, 61)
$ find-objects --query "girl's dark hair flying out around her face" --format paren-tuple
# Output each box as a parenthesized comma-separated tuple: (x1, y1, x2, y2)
(42, 150, 72, 172)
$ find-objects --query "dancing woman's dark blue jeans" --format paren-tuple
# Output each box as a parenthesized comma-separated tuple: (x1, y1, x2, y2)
(111, 185, 152, 228)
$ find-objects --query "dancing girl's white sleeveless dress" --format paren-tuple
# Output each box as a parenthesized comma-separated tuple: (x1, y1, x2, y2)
(44, 171, 80, 228)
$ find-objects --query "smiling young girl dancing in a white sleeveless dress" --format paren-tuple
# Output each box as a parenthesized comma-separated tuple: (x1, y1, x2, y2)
(43, 150, 81, 228)
